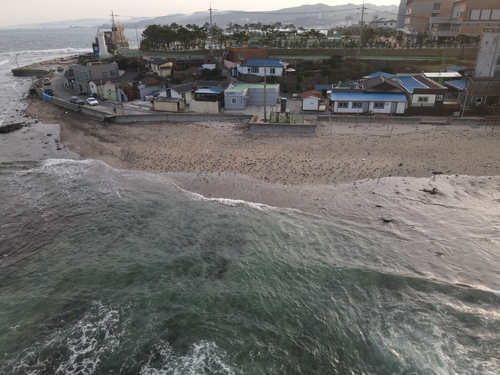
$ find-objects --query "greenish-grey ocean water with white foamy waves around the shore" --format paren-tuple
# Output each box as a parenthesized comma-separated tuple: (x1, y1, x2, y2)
(0, 29, 500, 375)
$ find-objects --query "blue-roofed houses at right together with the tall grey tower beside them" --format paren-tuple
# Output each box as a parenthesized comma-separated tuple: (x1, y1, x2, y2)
(304, 27, 500, 116)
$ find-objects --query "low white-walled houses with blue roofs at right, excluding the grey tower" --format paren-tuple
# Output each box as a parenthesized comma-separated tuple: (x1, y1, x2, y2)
(328, 71, 500, 116)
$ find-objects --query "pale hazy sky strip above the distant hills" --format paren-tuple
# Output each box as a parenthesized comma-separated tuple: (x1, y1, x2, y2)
(0, 0, 399, 27)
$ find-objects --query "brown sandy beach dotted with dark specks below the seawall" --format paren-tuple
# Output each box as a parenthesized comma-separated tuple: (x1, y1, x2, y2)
(26, 99, 500, 207)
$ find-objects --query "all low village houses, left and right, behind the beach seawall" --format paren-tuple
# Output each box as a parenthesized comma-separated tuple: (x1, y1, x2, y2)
(65, 25, 500, 116)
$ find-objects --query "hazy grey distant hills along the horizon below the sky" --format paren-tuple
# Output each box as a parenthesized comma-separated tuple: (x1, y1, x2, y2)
(0, 0, 398, 28)
